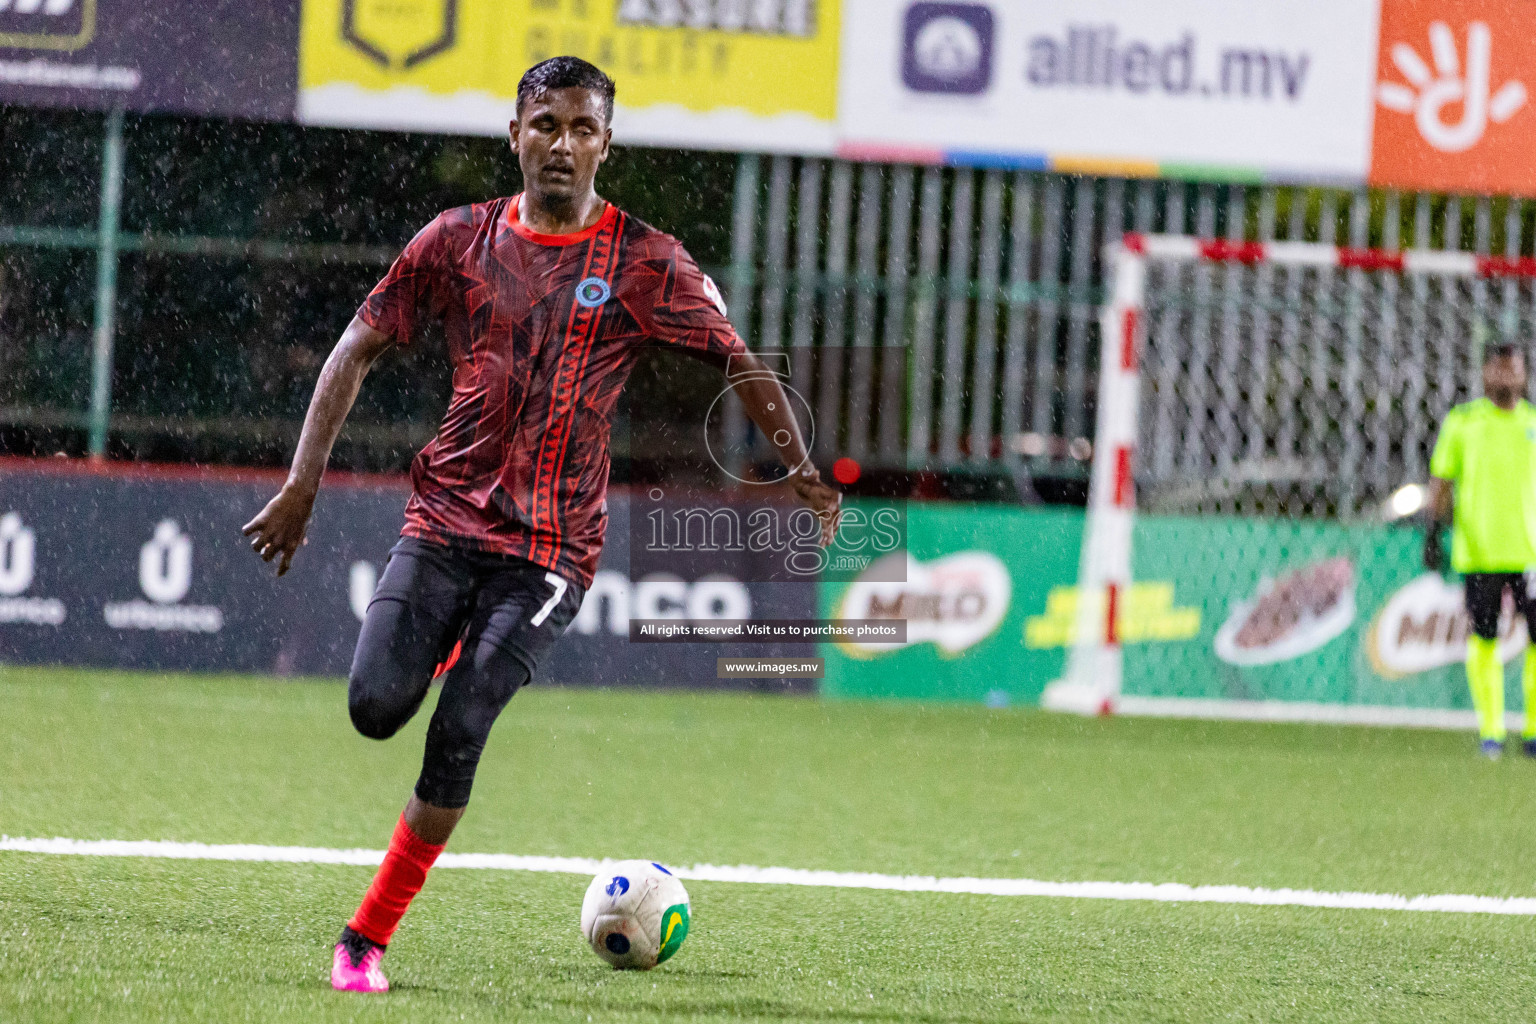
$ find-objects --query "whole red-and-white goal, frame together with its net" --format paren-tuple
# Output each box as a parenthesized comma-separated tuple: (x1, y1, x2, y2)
(1043, 235, 1536, 712)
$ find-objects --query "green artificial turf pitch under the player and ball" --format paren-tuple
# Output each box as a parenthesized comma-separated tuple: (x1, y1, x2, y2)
(0, 669, 1536, 1021)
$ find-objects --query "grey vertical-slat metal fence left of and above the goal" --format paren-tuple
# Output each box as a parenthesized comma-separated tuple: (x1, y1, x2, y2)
(734, 157, 1536, 473)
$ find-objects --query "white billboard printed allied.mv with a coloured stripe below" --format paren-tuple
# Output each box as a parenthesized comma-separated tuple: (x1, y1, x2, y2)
(837, 0, 1379, 181)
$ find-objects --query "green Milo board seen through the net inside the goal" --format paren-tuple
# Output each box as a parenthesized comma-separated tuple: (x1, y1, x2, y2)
(1124, 516, 1527, 709)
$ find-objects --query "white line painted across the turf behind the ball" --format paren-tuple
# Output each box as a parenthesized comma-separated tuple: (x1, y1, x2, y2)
(9, 835, 1536, 917)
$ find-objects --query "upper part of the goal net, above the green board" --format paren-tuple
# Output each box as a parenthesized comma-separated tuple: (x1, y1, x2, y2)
(1138, 259, 1536, 517)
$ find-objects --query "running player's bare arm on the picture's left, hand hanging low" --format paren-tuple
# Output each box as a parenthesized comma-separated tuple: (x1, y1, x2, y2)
(241, 318, 395, 576)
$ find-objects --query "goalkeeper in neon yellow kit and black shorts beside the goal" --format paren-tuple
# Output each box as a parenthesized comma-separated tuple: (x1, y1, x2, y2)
(1424, 344, 1536, 758)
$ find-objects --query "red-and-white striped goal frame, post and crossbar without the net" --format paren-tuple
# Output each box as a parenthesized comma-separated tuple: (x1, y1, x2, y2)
(1041, 233, 1536, 714)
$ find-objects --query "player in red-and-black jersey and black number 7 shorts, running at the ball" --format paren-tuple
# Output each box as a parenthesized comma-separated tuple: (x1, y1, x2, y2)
(244, 57, 840, 992)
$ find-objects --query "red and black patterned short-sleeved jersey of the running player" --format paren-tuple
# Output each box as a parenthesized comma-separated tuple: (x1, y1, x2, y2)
(358, 198, 745, 586)
